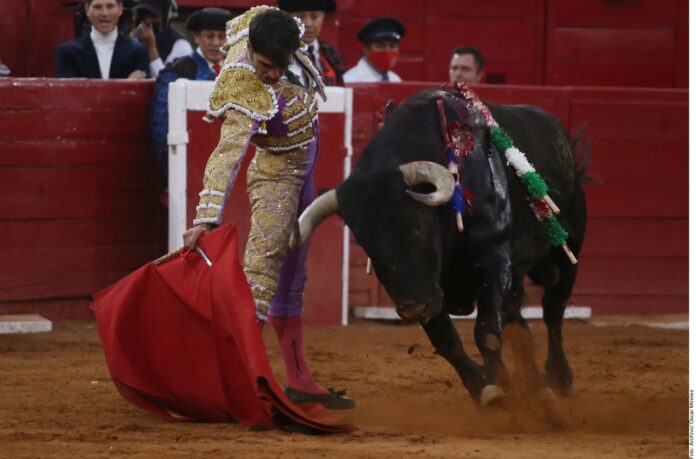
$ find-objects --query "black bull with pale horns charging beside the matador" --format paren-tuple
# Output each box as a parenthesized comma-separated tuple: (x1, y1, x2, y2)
(291, 89, 586, 403)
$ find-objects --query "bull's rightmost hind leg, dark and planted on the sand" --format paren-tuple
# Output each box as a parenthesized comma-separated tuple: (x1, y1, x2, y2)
(541, 249, 577, 394)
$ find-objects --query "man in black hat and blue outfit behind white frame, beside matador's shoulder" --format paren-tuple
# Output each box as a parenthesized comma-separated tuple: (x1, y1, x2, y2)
(150, 8, 232, 183)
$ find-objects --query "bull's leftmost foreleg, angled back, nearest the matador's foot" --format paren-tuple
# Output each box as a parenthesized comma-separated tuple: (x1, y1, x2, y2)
(422, 310, 486, 401)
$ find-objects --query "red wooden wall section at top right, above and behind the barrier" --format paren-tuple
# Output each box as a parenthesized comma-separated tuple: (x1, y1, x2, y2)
(544, 0, 688, 87)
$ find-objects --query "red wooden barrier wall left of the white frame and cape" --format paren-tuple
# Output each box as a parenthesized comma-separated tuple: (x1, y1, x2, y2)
(0, 79, 166, 318)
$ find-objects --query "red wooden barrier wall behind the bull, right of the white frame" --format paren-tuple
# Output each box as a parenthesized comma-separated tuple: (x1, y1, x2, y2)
(350, 83, 689, 314)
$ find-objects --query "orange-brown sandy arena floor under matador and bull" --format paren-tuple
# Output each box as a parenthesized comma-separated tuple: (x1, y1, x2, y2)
(0, 315, 688, 458)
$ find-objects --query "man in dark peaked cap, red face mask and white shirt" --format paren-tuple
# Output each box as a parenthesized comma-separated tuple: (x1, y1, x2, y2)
(343, 18, 405, 83)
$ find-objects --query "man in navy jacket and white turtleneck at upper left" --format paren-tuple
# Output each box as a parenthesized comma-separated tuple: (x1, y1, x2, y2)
(56, 0, 150, 80)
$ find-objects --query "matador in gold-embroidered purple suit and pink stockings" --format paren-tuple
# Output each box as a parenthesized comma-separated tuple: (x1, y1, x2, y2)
(183, 6, 355, 408)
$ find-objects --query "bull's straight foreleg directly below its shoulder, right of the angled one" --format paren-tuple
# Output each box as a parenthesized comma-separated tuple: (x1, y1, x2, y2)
(474, 245, 510, 392)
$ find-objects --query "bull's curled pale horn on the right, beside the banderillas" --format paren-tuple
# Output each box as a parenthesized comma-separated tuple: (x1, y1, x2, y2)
(399, 161, 454, 206)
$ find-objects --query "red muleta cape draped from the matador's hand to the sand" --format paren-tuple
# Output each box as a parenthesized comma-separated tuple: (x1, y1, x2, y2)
(92, 225, 353, 433)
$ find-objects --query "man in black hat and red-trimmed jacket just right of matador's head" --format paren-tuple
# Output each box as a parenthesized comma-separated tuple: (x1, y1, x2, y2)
(278, 0, 346, 86)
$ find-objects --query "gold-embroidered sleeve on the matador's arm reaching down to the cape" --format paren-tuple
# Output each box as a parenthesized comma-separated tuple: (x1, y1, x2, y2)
(193, 110, 257, 225)
